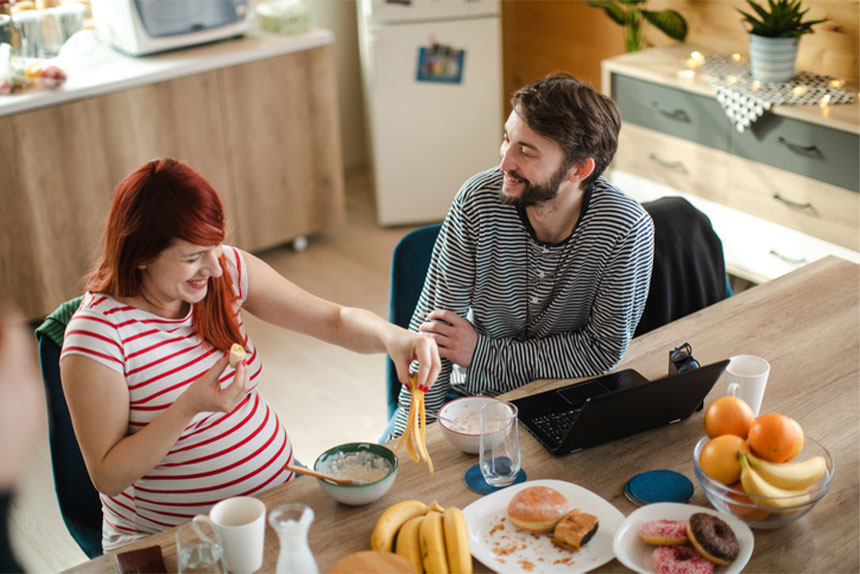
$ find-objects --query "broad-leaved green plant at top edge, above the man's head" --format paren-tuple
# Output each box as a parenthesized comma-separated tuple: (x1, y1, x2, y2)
(588, 0, 687, 52)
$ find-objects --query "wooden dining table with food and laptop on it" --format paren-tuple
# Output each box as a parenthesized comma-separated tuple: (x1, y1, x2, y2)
(69, 257, 860, 572)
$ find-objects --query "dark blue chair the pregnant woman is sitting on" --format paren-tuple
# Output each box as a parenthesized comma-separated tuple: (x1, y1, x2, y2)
(36, 297, 102, 558)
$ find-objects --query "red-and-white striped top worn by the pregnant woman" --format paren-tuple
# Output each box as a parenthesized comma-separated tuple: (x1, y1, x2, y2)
(60, 246, 293, 552)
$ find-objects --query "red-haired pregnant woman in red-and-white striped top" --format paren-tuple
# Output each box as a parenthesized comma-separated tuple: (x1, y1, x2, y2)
(60, 158, 440, 551)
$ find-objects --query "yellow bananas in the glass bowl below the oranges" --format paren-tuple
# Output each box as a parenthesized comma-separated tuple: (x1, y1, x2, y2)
(738, 451, 827, 508)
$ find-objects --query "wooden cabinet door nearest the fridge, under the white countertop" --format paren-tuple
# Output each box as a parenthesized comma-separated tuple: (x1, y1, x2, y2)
(217, 46, 345, 250)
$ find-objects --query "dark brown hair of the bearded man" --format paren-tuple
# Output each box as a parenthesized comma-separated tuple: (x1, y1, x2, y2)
(511, 74, 621, 187)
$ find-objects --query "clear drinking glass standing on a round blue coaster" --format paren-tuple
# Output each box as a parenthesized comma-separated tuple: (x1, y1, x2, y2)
(479, 401, 520, 488)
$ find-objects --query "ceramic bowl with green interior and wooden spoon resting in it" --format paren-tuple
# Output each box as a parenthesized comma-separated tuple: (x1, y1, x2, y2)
(314, 442, 397, 506)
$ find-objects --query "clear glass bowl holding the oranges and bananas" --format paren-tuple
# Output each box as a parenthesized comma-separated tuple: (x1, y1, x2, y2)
(693, 436, 833, 529)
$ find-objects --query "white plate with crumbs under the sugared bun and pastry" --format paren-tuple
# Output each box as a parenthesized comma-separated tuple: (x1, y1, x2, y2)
(463, 480, 624, 573)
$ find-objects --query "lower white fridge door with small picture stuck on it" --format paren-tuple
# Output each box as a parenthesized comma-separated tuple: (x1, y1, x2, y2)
(364, 17, 504, 225)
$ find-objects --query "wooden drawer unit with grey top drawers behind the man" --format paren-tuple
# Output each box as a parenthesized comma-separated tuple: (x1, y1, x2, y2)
(602, 46, 860, 283)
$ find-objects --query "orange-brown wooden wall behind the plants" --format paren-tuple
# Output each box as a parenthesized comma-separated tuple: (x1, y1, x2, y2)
(502, 0, 860, 100)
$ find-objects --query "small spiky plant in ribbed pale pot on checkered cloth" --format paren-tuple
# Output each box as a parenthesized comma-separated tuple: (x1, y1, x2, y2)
(737, 0, 827, 82)
